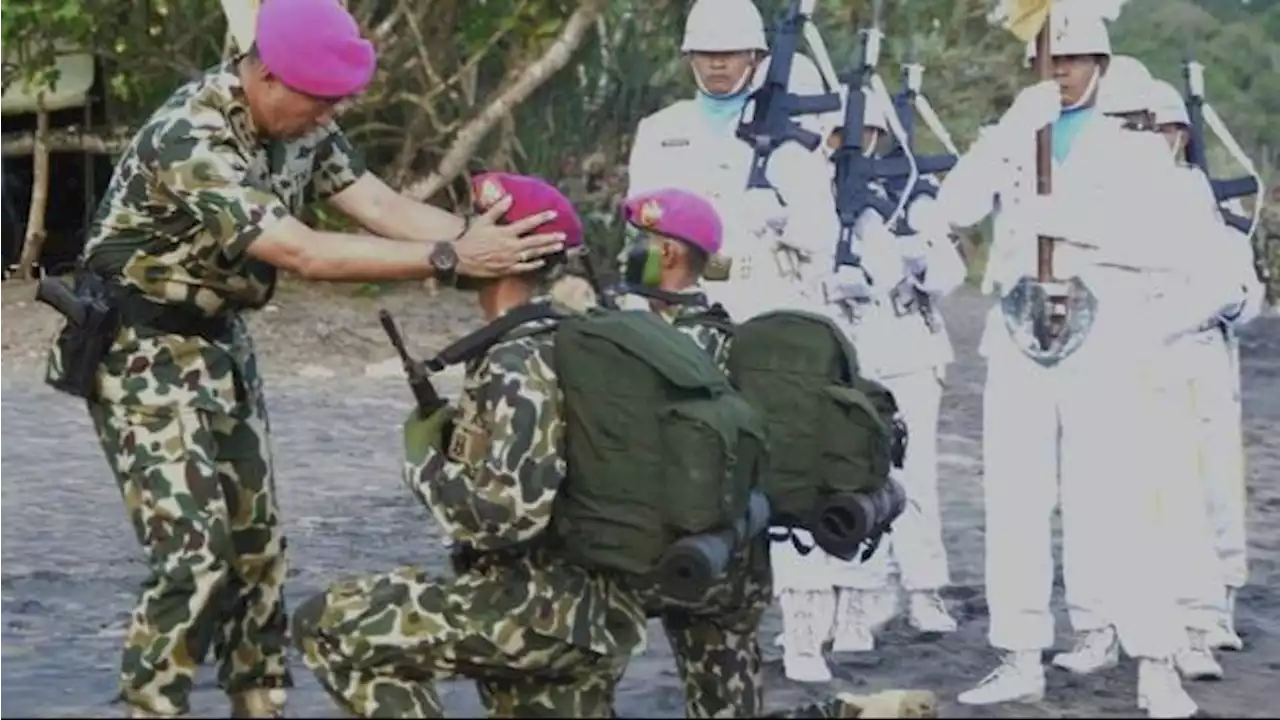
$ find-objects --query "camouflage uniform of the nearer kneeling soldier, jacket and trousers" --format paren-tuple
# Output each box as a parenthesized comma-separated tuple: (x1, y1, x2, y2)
(293, 304, 645, 717)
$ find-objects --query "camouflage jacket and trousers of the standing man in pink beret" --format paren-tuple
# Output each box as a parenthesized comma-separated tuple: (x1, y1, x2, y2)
(47, 60, 365, 715)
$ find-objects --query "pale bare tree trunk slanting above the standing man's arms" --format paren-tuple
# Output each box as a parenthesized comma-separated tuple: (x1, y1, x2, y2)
(403, 0, 603, 200)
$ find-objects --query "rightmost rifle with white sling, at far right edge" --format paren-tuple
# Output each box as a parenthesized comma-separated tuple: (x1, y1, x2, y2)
(1183, 58, 1262, 237)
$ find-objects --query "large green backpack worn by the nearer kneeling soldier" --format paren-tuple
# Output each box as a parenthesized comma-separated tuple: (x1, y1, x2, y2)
(460, 299, 769, 600)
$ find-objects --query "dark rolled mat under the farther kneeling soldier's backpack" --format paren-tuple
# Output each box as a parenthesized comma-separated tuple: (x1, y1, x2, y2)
(813, 478, 906, 560)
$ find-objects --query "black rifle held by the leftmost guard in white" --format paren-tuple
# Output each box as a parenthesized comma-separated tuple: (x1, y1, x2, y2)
(735, 0, 840, 188)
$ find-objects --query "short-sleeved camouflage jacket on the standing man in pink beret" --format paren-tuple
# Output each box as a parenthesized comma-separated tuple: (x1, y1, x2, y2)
(49, 64, 365, 411)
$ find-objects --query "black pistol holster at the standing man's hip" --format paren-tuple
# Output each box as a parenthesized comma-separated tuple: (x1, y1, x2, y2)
(36, 270, 120, 400)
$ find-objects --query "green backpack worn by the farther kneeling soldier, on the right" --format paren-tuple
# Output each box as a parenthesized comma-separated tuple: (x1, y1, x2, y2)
(685, 307, 906, 559)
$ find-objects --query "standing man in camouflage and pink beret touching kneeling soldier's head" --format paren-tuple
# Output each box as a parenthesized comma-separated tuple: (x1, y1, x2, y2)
(47, 0, 559, 717)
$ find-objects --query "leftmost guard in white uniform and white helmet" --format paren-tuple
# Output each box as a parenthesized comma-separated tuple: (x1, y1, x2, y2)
(627, 0, 840, 683)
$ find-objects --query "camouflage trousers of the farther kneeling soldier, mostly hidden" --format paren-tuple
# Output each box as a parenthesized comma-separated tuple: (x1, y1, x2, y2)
(646, 536, 773, 717)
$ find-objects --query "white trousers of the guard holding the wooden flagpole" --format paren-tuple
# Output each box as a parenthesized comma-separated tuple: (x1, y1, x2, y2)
(983, 336, 1185, 657)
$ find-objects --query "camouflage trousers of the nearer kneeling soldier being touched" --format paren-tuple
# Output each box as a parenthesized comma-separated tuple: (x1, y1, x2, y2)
(293, 568, 630, 717)
